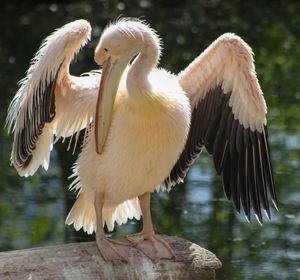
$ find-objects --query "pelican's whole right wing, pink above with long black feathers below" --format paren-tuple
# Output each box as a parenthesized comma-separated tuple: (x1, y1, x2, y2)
(164, 33, 276, 223)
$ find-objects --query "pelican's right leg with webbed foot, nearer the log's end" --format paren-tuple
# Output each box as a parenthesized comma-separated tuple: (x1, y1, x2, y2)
(127, 192, 176, 262)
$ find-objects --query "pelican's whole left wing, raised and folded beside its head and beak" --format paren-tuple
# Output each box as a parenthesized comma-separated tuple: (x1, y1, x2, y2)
(7, 20, 100, 176)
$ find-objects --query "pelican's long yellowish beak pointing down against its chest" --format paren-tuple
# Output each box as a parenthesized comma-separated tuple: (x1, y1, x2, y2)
(95, 53, 130, 154)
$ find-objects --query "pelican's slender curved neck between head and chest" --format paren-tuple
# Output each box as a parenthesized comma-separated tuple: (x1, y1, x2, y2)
(126, 38, 160, 102)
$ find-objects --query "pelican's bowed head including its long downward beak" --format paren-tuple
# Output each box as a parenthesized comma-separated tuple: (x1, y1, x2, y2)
(95, 19, 160, 153)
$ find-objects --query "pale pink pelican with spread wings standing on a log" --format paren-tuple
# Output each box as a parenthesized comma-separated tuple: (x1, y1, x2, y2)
(7, 19, 277, 261)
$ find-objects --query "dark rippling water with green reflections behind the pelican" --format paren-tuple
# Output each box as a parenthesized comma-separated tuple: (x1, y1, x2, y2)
(0, 0, 300, 279)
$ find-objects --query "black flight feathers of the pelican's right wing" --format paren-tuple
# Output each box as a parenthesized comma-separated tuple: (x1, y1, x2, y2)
(164, 86, 277, 223)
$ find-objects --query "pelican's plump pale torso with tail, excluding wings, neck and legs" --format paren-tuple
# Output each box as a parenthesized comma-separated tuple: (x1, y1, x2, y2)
(67, 69, 190, 232)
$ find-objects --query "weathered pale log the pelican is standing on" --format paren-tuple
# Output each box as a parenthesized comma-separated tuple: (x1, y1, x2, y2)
(0, 236, 222, 280)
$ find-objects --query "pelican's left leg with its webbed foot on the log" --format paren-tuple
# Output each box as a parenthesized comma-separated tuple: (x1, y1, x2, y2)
(94, 192, 129, 262)
